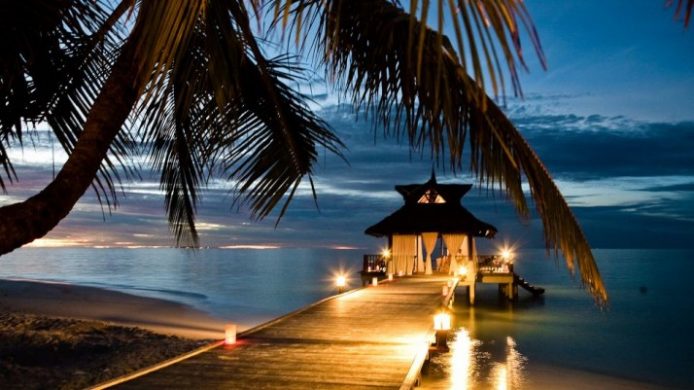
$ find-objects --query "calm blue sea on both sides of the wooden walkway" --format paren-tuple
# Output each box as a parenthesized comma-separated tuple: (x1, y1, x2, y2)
(0, 248, 694, 388)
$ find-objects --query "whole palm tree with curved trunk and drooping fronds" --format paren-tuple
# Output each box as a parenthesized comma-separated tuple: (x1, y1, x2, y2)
(6, 0, 694, 303)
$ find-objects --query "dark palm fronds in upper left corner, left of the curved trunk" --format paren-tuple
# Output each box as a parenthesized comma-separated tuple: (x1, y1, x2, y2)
(0, 0, 134, 204)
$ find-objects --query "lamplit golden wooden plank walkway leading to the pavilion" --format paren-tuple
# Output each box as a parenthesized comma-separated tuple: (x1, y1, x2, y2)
(113, 277, 448, 389)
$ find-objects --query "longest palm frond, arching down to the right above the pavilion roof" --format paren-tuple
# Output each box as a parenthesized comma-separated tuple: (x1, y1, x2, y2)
(304, 1, 607, 304)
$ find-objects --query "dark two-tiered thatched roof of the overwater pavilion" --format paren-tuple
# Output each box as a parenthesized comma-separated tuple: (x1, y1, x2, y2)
(365, 173, 497, 238)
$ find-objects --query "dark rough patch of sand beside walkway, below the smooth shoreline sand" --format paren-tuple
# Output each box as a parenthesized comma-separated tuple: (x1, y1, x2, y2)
(0, 312, 208, 389)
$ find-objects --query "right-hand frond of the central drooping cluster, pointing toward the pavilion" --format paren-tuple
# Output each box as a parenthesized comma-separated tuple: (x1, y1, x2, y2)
(227, 2, 344, 222)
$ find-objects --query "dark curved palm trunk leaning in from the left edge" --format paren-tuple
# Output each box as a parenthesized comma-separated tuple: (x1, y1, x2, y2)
(0, 36, 143, 255)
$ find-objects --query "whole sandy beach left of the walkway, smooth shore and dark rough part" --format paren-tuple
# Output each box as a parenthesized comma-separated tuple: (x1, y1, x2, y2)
(0, 280, 223, 389)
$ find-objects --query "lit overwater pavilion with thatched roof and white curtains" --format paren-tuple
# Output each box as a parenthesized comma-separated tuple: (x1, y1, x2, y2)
(362, 172, 544, 303)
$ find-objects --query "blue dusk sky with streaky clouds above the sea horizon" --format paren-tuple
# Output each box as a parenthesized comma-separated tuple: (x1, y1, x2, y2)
(0, 0, 694, 251)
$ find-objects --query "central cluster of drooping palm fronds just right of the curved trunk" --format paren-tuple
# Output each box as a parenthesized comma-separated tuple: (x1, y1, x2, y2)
(138, 0, 348, 243)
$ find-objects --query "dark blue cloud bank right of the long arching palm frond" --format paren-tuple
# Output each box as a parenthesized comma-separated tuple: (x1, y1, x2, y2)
(511, 113, 694, 178)
